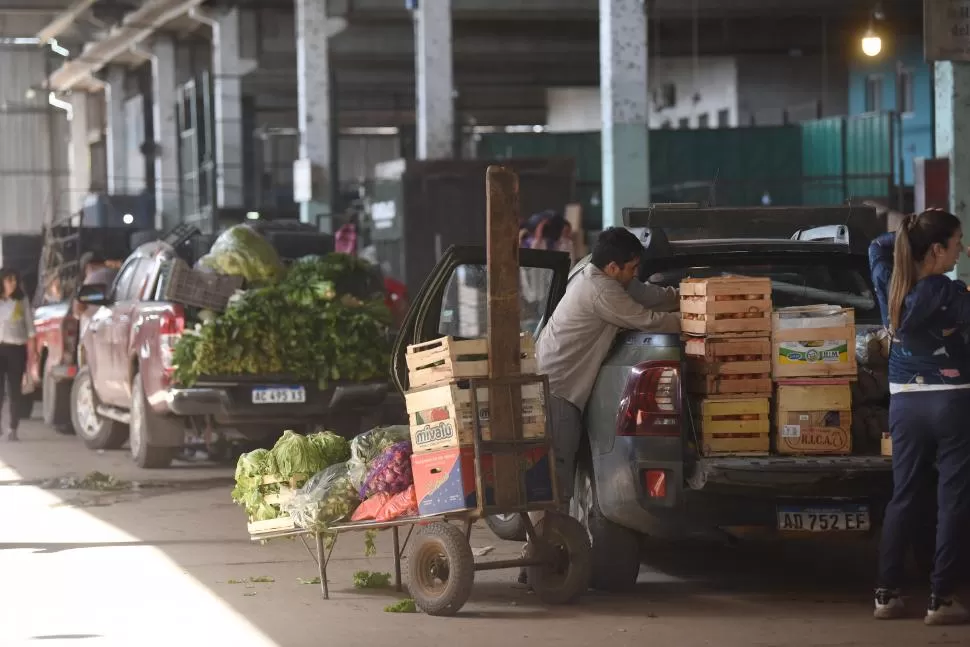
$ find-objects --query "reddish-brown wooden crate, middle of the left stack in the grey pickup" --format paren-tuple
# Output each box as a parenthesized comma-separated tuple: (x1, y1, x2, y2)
(684, 337, 771, 395)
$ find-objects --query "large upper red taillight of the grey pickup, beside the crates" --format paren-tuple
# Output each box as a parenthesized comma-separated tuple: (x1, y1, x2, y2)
(616, 361, 681, 436)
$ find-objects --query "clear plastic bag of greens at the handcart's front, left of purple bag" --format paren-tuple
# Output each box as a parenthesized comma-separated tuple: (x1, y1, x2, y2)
(283, 463, 360, 532)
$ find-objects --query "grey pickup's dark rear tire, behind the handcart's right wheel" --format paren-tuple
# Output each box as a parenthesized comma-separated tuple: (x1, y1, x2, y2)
(569, 457, 640, 592)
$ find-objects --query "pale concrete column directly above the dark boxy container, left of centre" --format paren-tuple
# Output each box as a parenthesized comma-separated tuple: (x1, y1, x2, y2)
(414, 0, 455, 159)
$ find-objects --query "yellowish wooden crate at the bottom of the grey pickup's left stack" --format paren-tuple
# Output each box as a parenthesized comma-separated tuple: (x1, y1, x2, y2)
(700, 396, 771, 456)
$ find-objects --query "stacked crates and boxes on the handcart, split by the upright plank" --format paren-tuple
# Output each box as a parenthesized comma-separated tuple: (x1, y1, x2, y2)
(405, 335, 552, 515)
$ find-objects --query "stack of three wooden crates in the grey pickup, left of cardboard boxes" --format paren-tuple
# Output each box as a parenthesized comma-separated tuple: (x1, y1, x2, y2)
(680, 276, 772, 456)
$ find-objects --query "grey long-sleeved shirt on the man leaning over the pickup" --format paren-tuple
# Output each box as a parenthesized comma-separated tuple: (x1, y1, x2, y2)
(536, 264, 680, 411)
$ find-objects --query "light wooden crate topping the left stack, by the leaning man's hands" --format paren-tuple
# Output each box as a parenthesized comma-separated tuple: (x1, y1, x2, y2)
(680, 276, 771, 336)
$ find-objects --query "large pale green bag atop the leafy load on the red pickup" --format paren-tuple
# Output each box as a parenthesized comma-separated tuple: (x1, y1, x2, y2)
(198, 225, 283, 285)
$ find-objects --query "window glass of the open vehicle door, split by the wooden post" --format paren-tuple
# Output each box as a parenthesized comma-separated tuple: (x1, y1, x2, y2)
(438, 265, 554, 339)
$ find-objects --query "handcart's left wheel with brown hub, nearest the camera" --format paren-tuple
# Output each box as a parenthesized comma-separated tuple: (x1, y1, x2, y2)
(408, 522, 475, 616)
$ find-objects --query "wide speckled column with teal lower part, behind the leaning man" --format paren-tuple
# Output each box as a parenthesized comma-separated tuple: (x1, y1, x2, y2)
(600, 0, 650, 228)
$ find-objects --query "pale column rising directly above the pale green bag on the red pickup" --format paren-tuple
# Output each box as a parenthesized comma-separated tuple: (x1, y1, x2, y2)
(212, 8, 257, 207)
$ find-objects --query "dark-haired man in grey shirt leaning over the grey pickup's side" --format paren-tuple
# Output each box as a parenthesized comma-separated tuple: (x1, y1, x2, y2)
(536, 227, 680, 512)
